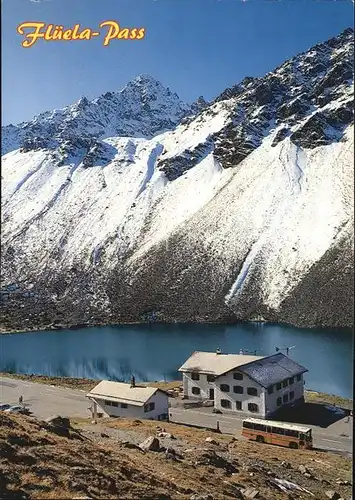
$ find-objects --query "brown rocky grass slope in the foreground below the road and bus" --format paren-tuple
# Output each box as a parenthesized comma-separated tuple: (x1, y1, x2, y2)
(0, 412, 352, 500)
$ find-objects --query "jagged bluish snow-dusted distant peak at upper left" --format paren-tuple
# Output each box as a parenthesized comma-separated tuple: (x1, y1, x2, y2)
(2, 75, 196, 154)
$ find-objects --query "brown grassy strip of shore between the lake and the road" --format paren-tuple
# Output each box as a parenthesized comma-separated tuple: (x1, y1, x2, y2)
(0, 372, 353, 410)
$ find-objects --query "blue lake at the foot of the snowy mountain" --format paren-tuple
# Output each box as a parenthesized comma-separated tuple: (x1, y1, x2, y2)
(0, 323, 353, 397)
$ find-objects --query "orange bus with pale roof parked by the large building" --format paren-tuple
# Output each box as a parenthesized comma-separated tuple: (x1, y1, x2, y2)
(242, 418, 313, 449)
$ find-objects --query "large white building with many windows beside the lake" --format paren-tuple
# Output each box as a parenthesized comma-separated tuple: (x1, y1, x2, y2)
(179, 351, 308, 418)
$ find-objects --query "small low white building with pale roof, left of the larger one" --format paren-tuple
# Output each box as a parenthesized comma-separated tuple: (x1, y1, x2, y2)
(86, 380, 169, 420)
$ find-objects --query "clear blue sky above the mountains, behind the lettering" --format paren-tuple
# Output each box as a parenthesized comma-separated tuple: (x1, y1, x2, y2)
(2, 0, 353, 125)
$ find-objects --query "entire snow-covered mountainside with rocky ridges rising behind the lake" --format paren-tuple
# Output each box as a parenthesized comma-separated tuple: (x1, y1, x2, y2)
(2, 29, 353, 328)
